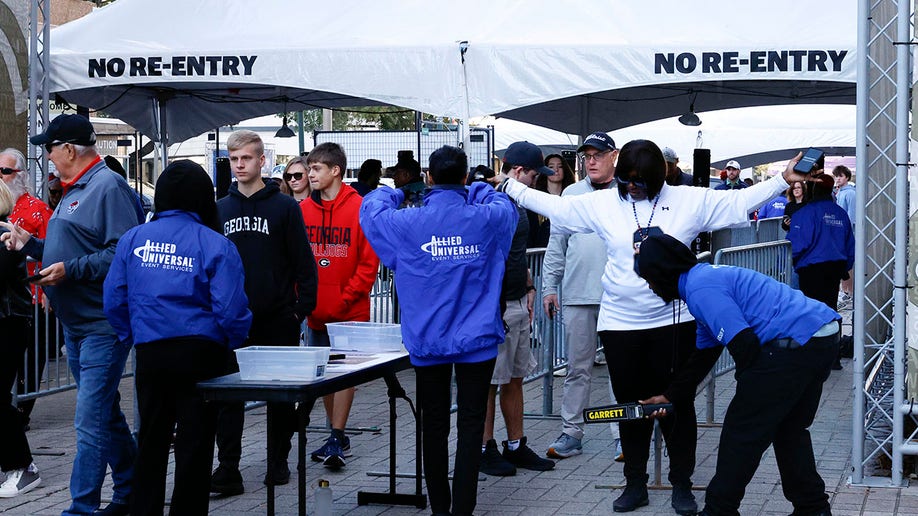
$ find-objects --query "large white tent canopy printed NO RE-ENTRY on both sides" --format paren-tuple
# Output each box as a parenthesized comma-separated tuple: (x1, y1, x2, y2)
(49, 0, 856, 142)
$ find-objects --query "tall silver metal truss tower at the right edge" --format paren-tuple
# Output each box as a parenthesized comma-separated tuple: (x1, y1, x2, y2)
(851, 0, 918, 487)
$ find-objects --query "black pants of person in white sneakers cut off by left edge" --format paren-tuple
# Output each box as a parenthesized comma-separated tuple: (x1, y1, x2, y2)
(0, 316, 32, 471)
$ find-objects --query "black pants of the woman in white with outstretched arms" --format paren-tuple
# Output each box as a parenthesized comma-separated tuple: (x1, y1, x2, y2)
(599, 321, 698, 487)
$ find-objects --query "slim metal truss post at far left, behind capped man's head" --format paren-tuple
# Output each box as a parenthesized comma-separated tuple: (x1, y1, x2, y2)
(28, 0, 51, 192)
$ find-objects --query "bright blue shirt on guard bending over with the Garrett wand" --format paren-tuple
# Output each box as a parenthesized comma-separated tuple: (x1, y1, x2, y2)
(679, 263, 841, 349)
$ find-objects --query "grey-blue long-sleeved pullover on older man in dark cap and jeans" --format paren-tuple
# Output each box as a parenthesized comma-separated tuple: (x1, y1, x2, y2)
(22, 161, 138, 336)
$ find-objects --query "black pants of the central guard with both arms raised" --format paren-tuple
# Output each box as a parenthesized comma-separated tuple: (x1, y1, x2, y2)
(414, 359, 494, 516)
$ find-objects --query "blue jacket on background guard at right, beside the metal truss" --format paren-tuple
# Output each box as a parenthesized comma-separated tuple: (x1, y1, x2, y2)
(787, 198, 854, 270)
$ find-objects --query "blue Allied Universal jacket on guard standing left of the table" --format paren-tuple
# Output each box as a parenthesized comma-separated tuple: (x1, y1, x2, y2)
(105, 210, 252, 349)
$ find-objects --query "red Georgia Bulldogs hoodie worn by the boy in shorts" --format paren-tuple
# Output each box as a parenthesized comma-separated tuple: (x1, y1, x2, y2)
(300, 184, 379, 330)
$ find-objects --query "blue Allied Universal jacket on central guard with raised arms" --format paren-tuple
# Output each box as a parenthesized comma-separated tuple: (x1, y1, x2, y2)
(360, 183, 517, 366)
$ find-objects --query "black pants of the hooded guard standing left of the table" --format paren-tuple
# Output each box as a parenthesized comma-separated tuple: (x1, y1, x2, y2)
(131, 338, 229, 516)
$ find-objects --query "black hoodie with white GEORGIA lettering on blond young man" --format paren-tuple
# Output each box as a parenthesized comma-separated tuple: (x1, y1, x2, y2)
(217, 181, 316, 321)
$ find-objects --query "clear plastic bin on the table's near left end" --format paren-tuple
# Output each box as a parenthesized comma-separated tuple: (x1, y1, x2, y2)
(236, 346, 329, 381)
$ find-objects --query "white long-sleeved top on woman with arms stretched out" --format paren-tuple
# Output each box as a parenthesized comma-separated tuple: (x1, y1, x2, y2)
(505, 175, 788, 331)
